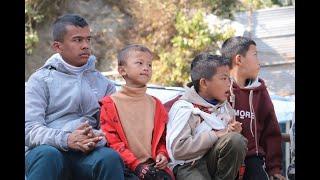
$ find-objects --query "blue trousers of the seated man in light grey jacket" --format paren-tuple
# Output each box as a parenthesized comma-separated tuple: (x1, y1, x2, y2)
(25, 145, 124, 180)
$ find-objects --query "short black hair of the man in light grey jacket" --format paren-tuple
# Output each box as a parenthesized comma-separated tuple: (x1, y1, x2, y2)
(52, 14, 88, 42)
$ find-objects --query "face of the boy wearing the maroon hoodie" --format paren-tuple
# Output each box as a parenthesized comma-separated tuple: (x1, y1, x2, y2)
(239, 45, 260, 79)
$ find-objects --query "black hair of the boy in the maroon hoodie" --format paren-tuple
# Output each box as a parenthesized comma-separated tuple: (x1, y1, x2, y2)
(221, 36, 256, 67)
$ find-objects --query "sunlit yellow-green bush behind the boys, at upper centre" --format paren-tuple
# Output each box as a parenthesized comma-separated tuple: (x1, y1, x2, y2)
(122, 0, 236, 86)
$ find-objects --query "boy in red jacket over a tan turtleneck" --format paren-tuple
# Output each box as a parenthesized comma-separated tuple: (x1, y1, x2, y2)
(100, 45, 174, 179)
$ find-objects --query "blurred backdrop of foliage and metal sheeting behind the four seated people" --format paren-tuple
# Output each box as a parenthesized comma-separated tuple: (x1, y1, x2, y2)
(25, 0, 295, 96)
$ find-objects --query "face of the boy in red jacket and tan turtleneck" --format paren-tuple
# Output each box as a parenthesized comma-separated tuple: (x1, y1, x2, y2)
(118, 51, 152, 87)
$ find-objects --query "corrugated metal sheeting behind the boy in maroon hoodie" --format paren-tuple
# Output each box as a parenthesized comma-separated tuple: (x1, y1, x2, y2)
(235, 6, 295, 96)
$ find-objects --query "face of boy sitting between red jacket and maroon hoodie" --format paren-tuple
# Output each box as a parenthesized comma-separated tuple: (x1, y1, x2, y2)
(205, 66, 230, 102)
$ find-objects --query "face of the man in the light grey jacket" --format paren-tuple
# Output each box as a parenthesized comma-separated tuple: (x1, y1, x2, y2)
(54, 25, 91, 67)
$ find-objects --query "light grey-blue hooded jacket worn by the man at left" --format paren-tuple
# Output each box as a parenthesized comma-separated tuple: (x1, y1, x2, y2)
(25, 53, 116, 153)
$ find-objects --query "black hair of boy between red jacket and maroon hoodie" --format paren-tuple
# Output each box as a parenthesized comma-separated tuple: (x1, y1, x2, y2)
(187, 53, 230, 92)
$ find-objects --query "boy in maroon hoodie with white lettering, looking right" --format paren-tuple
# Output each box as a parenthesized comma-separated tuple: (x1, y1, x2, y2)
(221, 36, 285, 180)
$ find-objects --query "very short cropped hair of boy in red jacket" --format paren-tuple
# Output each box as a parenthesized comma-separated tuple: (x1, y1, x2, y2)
(117, 44, 153, 66)
